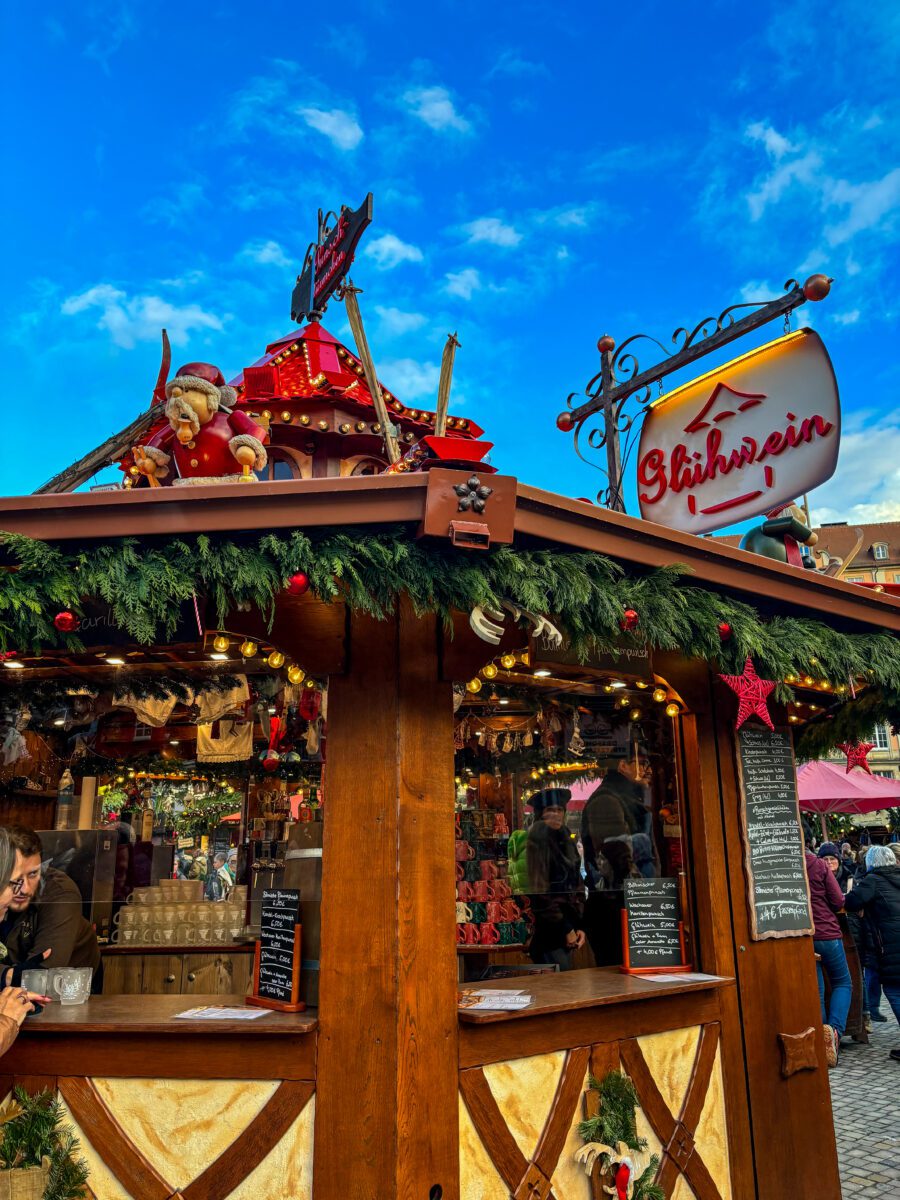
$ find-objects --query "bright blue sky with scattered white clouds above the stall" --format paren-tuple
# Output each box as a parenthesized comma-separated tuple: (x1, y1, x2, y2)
(0, 0, 900, 520)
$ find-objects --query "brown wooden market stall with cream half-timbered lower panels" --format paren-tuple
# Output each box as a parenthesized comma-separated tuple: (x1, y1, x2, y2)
(0, 467, 900, 1200)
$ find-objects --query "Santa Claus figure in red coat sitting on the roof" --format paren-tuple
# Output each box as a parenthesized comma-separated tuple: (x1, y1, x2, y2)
(133, 362, 268, 487)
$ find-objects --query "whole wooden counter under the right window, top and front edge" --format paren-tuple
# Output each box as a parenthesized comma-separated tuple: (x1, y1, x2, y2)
(458, 967, 734, 1069)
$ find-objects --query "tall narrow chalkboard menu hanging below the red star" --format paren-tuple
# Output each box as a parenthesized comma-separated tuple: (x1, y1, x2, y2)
(738, 728, 812, 942)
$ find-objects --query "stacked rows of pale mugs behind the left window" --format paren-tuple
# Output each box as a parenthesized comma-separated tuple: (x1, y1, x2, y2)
(112, 880, 247, 946)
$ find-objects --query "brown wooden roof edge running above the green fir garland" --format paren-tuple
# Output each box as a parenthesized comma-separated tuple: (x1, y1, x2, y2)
(0, 472, 900, 632)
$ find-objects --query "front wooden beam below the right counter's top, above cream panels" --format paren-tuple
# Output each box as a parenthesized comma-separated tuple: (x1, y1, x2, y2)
(460, 984, 733, 1069)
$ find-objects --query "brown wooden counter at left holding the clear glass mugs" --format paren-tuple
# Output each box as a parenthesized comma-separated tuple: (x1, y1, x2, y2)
(2, 996, 318, 1080)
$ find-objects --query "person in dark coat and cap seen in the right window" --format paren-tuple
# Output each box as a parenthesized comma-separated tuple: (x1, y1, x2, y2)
(526, 787, 584, 971)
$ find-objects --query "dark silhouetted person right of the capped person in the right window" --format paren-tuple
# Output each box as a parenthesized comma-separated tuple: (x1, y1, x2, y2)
(581, 752, 658, 966)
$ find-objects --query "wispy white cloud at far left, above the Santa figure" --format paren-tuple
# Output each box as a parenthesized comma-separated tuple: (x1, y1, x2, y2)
(61, 283, 222, 350)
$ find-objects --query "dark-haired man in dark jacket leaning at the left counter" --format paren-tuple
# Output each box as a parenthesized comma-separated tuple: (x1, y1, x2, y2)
(0, 826, 103, 994)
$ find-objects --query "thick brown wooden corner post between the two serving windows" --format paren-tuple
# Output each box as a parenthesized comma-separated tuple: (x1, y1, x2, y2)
(313, 601, 460, 1200)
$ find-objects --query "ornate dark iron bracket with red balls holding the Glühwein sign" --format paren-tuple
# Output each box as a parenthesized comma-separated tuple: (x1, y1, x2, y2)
(557, 275, 832, 512)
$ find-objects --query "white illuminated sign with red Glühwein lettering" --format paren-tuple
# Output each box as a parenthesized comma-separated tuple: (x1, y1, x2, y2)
(637, 329, 840, 533)
